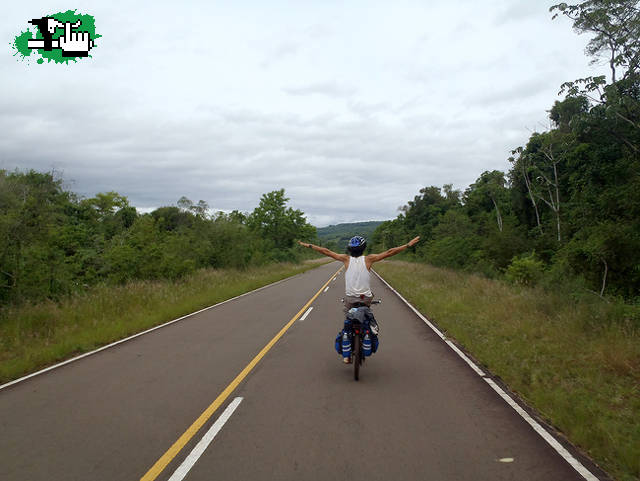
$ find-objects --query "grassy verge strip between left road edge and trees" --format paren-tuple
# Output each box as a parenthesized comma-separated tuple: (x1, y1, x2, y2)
(0, 261, 328, 384)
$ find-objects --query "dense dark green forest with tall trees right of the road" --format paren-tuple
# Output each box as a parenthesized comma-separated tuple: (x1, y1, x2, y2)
(373, 0, 640, 301)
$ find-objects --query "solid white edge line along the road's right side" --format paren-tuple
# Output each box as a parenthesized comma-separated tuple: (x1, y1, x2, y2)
(373, 271, 599, 481)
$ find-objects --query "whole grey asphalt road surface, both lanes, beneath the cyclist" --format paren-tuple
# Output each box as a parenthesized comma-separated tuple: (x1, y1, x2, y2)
(0, 263, 600, 481)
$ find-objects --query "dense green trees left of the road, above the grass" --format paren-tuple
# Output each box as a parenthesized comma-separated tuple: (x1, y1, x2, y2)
(0, 174, 315, 304)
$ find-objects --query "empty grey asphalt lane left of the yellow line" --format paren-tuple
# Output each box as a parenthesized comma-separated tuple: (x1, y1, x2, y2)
(0, 264, 339, 481)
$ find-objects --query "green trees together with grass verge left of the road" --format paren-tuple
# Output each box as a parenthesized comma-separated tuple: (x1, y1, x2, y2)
(0, 170, 324, 382)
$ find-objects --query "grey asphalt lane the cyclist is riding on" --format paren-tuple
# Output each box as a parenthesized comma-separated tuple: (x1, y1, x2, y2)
(171, 264, 583, 481)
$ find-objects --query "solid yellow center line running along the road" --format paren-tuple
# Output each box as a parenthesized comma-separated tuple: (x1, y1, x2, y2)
(140, 267, 342, 481)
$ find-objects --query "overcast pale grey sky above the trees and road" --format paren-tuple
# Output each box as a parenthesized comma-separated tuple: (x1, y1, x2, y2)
(0, 0, 606, 226)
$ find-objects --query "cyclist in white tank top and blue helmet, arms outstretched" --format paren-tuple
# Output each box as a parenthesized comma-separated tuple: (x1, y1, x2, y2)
(298, 236, 420, 363)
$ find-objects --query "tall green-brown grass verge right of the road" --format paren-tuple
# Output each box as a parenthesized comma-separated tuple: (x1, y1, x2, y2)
(376, 262, 640, 481)
